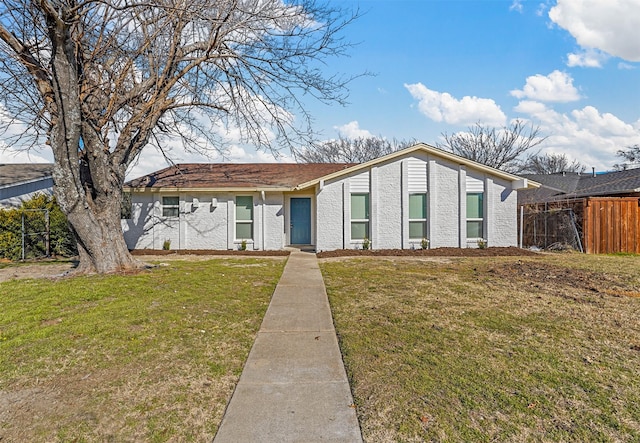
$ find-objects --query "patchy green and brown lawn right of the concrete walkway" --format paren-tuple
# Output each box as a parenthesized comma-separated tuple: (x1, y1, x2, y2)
(321, 254, 640, 443)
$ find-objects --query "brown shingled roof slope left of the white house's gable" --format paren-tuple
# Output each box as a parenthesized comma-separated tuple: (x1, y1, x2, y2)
(126, 163, 354, 189)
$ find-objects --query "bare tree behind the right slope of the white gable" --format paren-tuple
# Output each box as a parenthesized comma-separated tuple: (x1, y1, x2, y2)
(438, 120, 546, 173)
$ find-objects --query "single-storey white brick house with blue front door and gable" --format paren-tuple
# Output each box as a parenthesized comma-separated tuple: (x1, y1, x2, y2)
(123, 144, 536, 251)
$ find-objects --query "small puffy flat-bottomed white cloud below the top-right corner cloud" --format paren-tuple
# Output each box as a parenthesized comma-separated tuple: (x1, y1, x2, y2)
(511, 71, 580, 103)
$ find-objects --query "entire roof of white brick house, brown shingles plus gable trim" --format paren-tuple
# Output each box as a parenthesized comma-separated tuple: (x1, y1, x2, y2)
(125, 143, 539, 191)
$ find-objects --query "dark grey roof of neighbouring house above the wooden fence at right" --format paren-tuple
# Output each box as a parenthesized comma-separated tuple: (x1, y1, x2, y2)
(521, 168, 640, 202)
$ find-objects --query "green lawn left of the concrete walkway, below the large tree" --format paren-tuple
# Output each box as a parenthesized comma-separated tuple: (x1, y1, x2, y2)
(0, 259, 284, 441)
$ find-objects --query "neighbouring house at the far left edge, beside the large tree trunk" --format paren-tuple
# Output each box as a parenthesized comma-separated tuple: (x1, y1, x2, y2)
(0, 163, 53, 208)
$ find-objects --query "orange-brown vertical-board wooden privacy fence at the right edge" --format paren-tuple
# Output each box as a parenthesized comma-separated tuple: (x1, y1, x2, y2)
(582, 197, 640, 254)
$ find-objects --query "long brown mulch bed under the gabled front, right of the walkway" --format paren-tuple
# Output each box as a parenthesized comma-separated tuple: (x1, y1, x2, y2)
(316, 246, 539, 258)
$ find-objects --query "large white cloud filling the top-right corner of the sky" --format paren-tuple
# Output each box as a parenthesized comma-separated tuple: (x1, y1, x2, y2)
(549, 0, 640, 61)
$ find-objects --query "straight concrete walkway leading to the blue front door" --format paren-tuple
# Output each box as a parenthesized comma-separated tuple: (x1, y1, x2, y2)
(213, 251, 362, 443)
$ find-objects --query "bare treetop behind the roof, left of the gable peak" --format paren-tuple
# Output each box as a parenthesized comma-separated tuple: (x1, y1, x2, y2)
(296, 137, 414, 163)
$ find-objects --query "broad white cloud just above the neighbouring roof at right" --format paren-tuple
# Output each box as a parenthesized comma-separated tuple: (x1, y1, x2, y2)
(515, 101, 640, 171)
